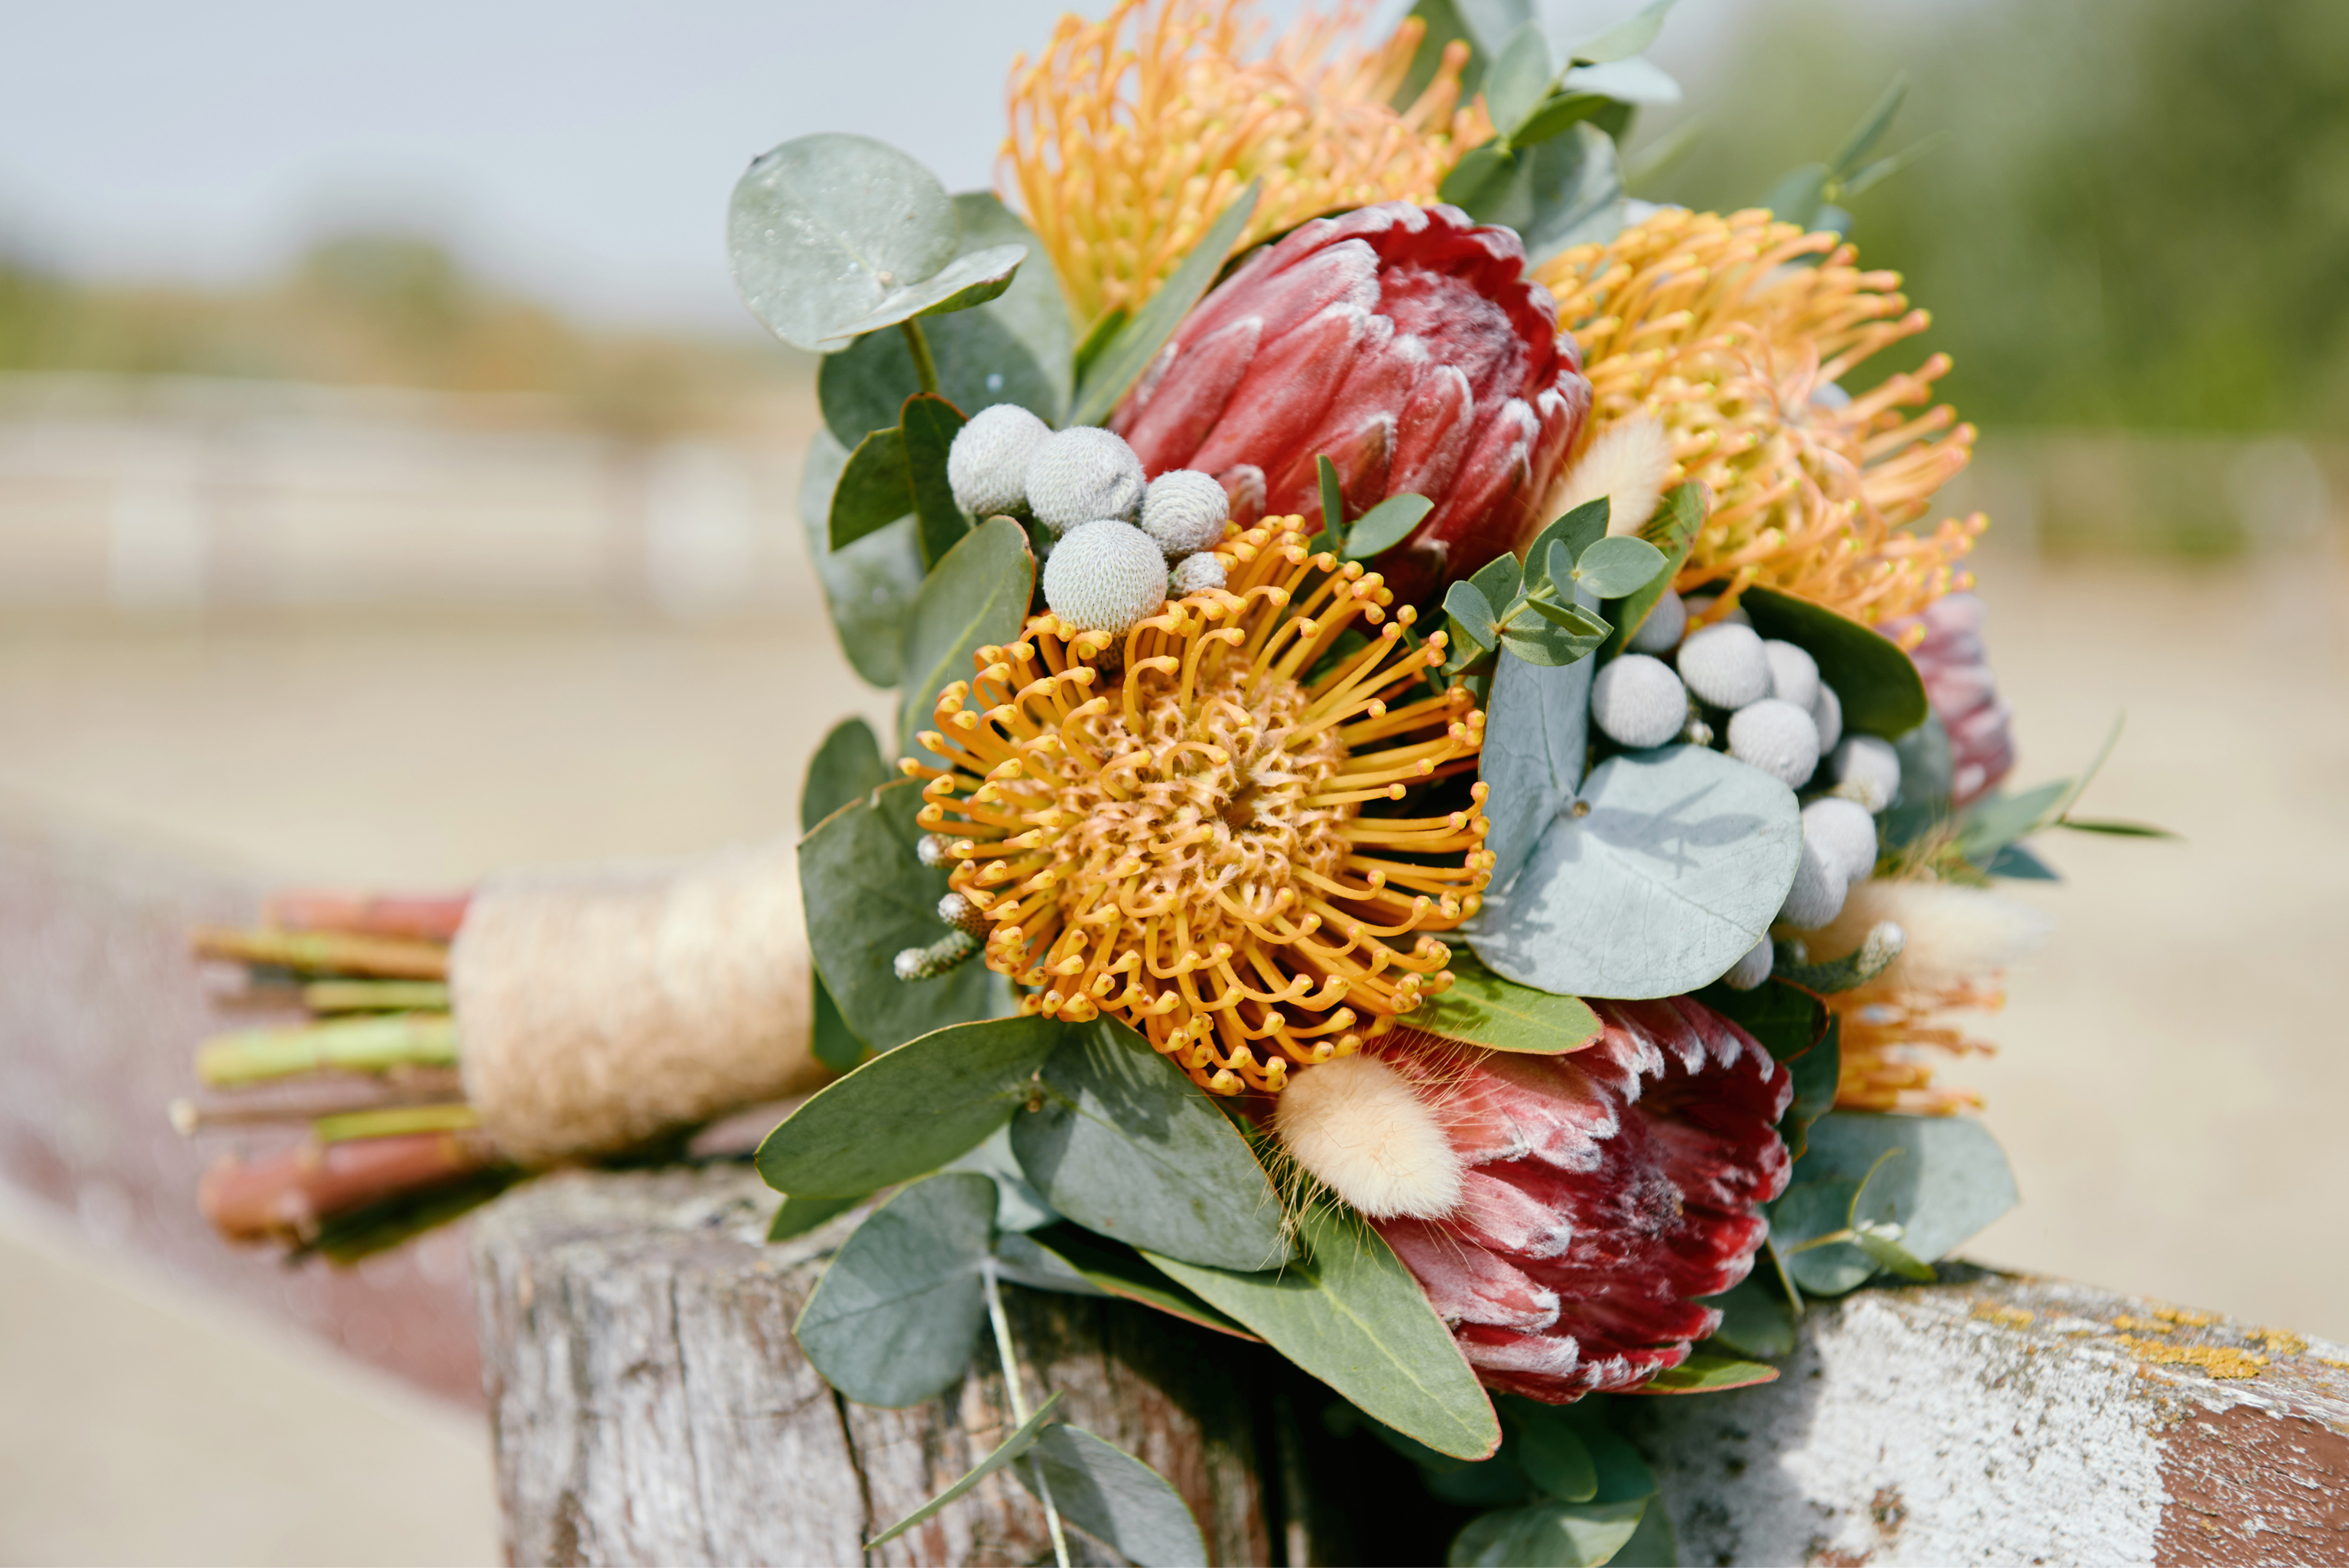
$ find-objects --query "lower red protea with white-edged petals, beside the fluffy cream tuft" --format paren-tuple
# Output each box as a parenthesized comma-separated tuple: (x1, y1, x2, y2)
(1372, 998, 1792, 1404)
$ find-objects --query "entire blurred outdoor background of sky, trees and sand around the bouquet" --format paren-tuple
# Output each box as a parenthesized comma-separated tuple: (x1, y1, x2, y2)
(0, 0, 2349, 1563)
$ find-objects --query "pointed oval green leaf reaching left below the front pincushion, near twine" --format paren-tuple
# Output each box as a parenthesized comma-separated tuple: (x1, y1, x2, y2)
(759, 1019, 1069, 1192)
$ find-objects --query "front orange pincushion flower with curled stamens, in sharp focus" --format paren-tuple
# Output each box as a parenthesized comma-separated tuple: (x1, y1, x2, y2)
(905, 516, 1492, 1094)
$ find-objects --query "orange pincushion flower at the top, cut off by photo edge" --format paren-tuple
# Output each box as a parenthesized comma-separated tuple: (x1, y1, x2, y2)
(1003, 0, 1492, 322)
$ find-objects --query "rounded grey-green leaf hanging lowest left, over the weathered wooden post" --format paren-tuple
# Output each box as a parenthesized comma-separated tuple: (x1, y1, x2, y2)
(791, 1171, 996, 1408)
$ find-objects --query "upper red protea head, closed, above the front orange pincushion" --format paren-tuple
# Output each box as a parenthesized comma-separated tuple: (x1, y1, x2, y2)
(1109, 202, 1590, 603)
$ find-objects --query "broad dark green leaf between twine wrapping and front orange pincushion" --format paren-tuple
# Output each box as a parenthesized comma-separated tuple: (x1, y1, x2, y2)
(785, 779, 989, 1047)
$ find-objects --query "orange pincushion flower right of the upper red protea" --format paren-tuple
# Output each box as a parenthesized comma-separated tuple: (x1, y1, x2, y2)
(1536, 209, 1985, 625)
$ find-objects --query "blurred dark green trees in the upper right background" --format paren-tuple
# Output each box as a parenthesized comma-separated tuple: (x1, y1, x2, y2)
(1633, 0, 2349, 432)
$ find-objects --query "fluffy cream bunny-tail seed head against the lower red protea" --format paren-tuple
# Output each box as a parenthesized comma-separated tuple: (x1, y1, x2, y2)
(1273, 1057, 1461, 1221)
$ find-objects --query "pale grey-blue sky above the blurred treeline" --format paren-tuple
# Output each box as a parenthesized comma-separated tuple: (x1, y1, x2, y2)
(0, 0, 1738, 329)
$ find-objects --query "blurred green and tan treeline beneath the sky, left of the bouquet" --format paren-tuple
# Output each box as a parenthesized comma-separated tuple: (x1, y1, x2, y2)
(0, 235, 813, 434)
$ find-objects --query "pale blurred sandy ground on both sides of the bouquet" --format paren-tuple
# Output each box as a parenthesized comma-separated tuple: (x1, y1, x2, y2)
(0, 535, 2349, 1561)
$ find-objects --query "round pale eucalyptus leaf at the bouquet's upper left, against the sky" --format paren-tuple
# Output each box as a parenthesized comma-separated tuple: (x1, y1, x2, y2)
(726, 131, 958, 352)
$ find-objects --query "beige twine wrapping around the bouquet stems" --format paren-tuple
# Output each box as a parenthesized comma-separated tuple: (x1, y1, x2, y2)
(449, 840, 827, 1167)
